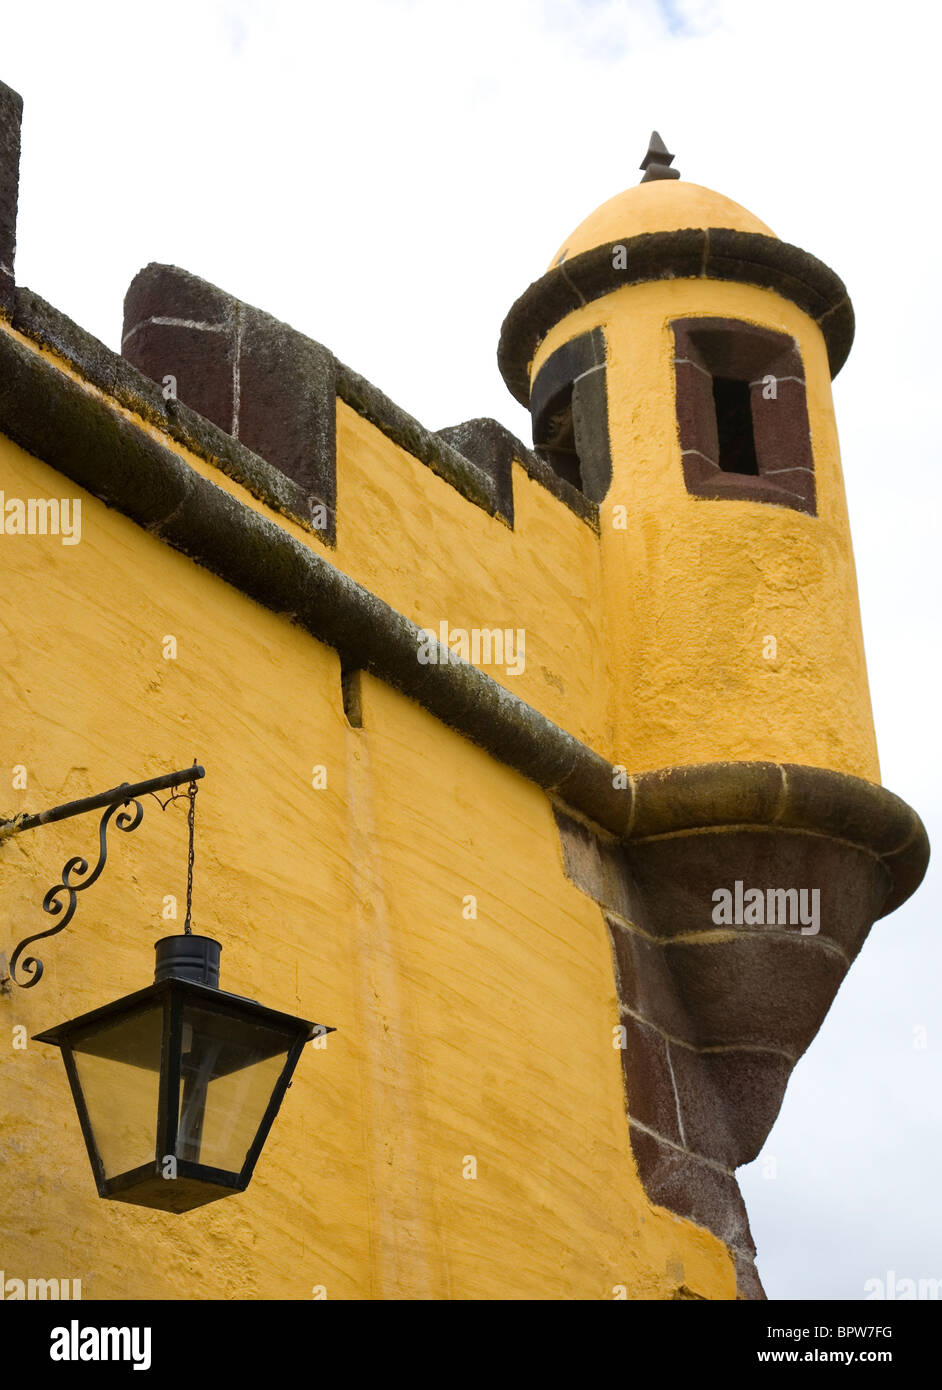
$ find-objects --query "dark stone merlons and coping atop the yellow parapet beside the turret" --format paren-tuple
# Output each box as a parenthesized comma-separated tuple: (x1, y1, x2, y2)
(122, 264, 596, 543)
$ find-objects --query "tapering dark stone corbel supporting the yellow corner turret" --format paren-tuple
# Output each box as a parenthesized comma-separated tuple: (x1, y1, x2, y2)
(557, 763, 929, 1298)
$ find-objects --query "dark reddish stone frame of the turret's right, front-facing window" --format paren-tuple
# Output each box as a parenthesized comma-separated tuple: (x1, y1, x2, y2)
(670, 317, 817, 516)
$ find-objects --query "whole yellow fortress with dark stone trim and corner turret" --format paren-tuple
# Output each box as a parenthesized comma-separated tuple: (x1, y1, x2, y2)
(0, 85, 928, 1300)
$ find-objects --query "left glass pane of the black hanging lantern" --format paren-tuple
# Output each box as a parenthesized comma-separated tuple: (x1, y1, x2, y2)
(67, 1004, 164, 1177)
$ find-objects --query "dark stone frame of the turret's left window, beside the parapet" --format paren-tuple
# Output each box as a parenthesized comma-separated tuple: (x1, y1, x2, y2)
(529, 328, 611, 503)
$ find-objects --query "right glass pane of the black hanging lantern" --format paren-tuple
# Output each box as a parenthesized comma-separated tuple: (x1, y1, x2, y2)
(176, 1004, 297, 1173)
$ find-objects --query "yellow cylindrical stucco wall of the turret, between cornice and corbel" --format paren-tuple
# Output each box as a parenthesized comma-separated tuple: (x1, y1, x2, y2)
(531, 276, 879, 781)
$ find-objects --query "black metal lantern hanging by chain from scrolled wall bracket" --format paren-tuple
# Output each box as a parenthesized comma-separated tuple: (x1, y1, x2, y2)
(0, 763, 335, 1212)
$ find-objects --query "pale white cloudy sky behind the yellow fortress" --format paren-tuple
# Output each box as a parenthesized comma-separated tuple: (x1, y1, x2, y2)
(0, 0, 942, 1298)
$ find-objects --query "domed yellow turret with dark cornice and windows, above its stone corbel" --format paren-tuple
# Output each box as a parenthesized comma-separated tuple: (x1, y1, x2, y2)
(500, 150, 879, 781)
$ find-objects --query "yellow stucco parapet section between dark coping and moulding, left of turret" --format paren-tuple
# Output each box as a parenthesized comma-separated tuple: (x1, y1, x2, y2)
(332, 400, 613, 758)
